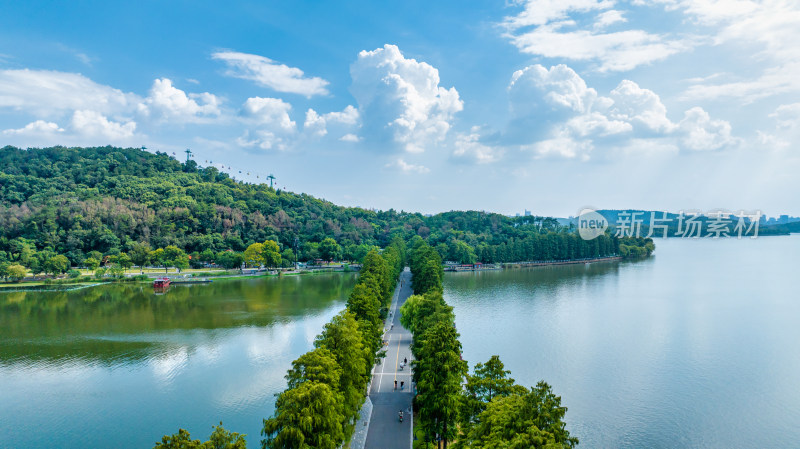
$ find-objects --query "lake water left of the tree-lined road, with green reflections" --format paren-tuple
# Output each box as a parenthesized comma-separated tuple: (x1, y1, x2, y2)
(0, 274, 355, 449)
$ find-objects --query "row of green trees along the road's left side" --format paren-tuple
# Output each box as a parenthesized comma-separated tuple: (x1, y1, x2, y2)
(262, 238, 405, 449)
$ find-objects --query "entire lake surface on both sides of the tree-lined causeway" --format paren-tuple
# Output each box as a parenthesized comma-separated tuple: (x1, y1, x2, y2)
(0, 236, 800, 449)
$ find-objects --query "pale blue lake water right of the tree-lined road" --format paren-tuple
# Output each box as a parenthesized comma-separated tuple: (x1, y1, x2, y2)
(445, 235, 800, 448)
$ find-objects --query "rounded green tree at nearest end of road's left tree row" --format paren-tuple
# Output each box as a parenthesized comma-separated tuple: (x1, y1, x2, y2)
(261, 381, 344, 449)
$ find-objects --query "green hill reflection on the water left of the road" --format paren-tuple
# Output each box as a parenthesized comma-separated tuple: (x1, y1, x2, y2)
(0, 275, 354, 364)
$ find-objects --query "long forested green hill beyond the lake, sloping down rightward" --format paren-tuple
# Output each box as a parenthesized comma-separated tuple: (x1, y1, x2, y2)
(0, 146, 618, 265)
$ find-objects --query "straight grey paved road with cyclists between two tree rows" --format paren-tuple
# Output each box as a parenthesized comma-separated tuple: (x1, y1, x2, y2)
(366, 269, 412, 449)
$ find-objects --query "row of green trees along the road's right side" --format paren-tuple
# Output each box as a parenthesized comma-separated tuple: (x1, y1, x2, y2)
(400, 238, 578, 449)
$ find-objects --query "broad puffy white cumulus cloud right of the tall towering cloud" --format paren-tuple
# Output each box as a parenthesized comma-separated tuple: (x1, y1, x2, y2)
(504, 64, 740, 159)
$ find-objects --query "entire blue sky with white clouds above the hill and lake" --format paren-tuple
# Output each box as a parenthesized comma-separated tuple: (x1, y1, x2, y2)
(0, 0, 800, 216)
